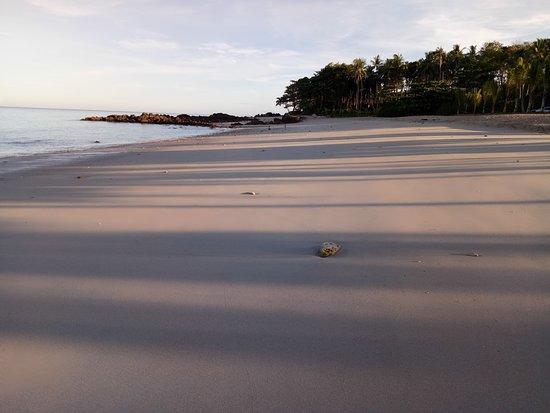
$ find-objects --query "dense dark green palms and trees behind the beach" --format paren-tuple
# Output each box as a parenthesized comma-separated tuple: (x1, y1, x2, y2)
(276, 39, 550, 116)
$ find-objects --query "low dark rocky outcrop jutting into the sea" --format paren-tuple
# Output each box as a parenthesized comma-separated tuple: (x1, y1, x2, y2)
(82, 112, 250, 127)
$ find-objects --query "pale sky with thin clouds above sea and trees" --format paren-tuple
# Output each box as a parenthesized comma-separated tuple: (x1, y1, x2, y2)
(0, 0, 550, 114)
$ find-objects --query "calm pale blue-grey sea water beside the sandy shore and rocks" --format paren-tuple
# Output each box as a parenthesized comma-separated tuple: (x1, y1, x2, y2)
(0, 107, 220, 161)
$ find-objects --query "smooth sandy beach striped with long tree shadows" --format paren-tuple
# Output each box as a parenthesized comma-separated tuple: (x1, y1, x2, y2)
(0, 118, 550, 412)
